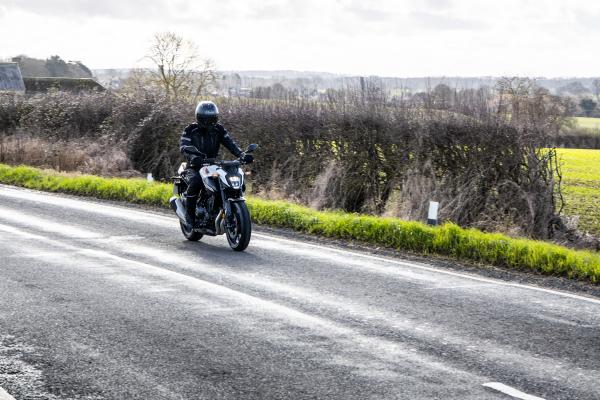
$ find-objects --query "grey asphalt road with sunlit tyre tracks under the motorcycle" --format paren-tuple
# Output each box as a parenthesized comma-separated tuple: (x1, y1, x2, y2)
(0, 186, 600, 400)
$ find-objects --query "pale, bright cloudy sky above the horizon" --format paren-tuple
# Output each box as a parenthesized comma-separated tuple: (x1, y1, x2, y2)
(0, 0, 600, 77)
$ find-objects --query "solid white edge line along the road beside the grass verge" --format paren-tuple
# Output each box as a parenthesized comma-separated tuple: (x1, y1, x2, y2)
(0, 185, 600, 304)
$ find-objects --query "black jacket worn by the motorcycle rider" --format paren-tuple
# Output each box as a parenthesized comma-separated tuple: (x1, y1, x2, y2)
(179, 124, 243, 163)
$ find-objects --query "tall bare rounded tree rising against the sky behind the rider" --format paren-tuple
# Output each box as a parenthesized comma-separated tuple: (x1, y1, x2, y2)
(147, 32, 217, 100)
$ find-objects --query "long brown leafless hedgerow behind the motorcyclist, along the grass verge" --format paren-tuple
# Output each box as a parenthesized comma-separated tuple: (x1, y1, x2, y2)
(0, 86, 566, 239)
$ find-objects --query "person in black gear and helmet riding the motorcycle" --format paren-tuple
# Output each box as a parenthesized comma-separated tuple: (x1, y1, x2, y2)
(179, 101, 254, 226)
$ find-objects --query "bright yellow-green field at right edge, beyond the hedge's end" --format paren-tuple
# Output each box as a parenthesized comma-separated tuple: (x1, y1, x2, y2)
(558, 149, 600, 236)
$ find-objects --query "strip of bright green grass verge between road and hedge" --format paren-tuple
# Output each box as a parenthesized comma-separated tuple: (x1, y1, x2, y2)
(0, 164, 600, 283)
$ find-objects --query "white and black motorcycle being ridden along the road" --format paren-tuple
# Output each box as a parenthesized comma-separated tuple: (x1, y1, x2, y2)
(169, 144, 258, 251)
